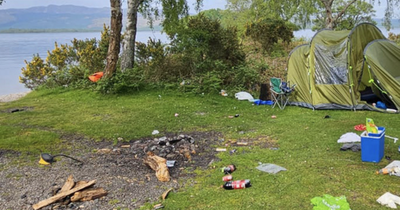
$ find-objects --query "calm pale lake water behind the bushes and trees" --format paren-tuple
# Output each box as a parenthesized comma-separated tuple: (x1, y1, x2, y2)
(0, 31, 168, 95)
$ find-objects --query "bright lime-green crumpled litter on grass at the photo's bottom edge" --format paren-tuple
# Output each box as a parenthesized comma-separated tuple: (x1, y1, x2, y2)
(311, 194, 350, 210)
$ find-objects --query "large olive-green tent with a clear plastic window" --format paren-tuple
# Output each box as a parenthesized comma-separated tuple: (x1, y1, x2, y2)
(287, 23, 400, 110)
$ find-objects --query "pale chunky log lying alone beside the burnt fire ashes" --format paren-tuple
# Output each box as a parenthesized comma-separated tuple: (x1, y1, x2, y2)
(143, 152, 170, 182)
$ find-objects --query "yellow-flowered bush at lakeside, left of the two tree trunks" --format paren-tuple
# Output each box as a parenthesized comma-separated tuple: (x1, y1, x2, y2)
(20, 27, 109, 89)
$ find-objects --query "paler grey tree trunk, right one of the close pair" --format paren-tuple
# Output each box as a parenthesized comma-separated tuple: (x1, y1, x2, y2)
(121, 0, 143, 71)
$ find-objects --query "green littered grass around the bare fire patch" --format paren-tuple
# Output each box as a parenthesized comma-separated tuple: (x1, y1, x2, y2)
(0, 89, 400, 209)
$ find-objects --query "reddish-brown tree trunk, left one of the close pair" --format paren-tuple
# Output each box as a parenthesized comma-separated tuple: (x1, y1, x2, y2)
(104, 0, 122, 78)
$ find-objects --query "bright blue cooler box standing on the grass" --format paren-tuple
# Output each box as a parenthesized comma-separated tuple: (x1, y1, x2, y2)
(361, 127, 385, 163)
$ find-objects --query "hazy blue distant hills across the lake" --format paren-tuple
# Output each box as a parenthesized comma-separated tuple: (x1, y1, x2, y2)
(0, 5, 160, 32)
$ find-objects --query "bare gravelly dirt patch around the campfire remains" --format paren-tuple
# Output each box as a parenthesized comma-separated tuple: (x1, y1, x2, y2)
(0, 132, 221, 210)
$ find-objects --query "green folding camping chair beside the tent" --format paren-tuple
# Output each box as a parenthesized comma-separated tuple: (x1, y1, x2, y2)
(270, 77, 296, 109)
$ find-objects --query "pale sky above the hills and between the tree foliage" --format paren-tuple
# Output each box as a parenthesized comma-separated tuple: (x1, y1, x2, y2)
(0, 0, 386, 18)
